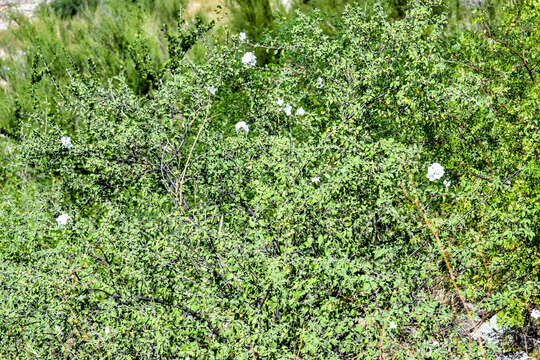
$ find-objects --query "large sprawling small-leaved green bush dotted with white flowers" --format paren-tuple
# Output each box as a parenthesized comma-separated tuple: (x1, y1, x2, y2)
(0, 0, 540, 359)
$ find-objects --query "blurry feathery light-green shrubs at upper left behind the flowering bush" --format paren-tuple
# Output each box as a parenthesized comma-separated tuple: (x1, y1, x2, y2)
(0, 0, 192, 137)
